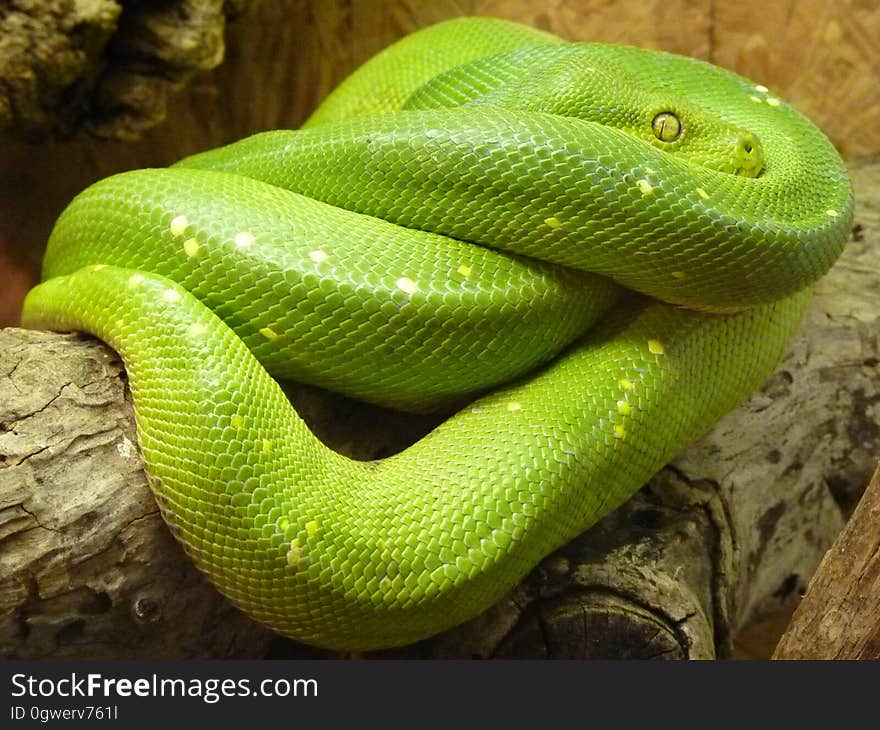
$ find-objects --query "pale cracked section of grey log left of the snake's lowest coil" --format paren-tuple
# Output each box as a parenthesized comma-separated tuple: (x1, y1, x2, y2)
(0, 329, 270, 659)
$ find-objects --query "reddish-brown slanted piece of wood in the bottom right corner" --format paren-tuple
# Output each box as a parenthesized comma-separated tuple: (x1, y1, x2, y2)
(773, 467, 880, 659)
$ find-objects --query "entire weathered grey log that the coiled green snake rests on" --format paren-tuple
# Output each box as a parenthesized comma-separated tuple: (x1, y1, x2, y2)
(0, 162, 880, 658)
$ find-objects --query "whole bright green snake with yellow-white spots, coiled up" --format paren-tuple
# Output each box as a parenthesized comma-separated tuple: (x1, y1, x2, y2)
(23, 18, 853, 650)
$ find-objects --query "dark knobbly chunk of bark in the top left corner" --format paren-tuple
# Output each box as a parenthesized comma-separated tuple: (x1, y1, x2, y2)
(0, 0, 251, 139)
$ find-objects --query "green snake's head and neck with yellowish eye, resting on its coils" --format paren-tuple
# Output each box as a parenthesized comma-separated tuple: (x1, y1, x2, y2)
(422, 43, 764, 177)
